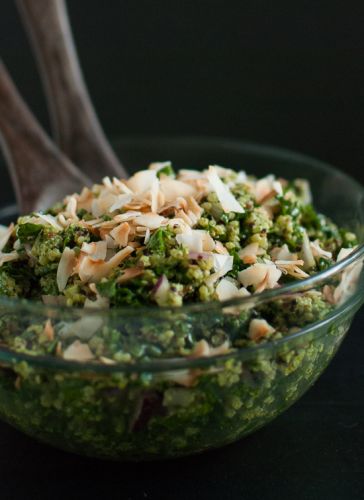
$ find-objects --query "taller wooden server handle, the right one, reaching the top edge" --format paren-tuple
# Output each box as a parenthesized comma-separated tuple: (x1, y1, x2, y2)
(17, 0, 127, 181)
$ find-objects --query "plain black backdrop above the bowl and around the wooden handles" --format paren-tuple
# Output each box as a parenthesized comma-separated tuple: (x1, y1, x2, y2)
(0, 0, 364, 182)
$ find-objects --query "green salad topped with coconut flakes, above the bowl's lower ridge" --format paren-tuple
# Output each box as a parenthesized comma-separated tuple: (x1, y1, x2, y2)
(0, 162, 358, 364)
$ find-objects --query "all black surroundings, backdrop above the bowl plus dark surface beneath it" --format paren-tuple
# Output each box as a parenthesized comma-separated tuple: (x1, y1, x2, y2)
(0, 0, 364, 500)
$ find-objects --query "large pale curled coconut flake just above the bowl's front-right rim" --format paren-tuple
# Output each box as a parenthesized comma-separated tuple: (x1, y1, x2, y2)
(238, 261, 282, 293)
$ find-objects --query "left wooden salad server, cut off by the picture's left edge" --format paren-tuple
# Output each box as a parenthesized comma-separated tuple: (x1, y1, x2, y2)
(0, 59, 91, 213)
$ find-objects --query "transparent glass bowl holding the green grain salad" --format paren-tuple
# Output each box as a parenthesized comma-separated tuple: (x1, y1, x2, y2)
(0, 138, 364, 460)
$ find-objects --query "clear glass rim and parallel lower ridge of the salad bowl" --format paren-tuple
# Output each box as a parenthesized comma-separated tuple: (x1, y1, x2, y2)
(0, 136, 364, 373)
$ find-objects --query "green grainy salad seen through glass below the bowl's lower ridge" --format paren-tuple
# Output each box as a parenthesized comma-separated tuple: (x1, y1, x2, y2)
(0, 315, 350, 460)
